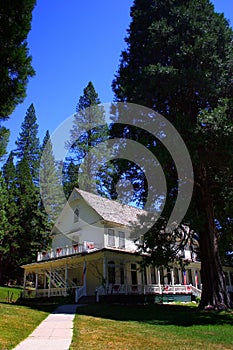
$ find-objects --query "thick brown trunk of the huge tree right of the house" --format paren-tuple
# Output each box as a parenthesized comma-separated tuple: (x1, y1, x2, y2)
(196, 166, 231, 310)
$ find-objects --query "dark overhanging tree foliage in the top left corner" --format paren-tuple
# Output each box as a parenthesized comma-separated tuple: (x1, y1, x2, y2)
(0, 0, 36, 120)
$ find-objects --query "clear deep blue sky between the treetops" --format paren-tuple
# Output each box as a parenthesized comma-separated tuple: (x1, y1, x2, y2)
(4, 0, 233, 151)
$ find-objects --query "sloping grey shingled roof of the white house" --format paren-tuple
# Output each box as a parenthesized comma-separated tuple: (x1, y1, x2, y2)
(74, 188, 148, 226)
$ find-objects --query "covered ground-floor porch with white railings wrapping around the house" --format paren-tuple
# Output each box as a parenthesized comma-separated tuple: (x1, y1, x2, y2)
(23, 248, 201, 302)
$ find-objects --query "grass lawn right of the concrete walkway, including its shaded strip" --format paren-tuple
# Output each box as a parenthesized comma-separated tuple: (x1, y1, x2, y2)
(70, 304, 233, 350)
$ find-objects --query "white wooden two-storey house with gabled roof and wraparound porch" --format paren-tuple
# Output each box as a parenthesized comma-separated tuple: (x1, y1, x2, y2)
(22, 189, 233, 302)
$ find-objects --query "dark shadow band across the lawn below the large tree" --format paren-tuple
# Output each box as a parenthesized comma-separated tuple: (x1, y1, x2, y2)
(77, 304, 233, 327)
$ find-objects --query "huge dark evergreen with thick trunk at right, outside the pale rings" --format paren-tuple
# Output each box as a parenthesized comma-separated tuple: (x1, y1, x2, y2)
(113, 0, 233, 309)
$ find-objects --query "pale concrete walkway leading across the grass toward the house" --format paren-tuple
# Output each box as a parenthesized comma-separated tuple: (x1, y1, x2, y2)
(14, 304, 77, 350)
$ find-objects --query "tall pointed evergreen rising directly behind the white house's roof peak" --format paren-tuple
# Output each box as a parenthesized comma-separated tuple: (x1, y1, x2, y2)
(65, 82, 109, 197)
